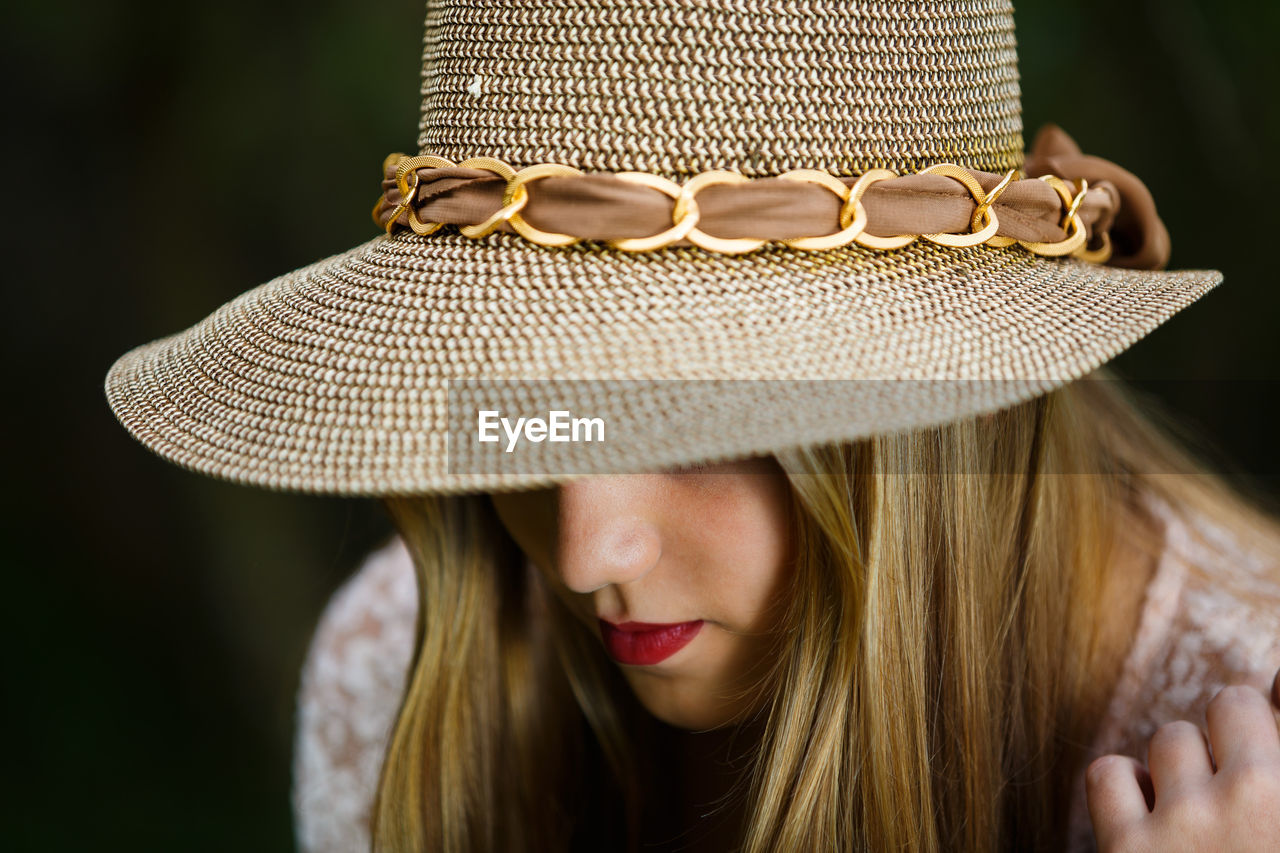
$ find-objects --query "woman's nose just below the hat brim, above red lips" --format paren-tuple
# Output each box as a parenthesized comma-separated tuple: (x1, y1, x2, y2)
(556, 474, 662, 593)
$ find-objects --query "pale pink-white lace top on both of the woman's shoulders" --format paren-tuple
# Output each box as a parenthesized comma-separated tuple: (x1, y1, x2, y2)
(293, 489, 1280, 853)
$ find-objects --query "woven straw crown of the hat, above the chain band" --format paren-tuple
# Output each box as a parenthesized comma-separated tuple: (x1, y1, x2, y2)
(419, 0, 1023, 178)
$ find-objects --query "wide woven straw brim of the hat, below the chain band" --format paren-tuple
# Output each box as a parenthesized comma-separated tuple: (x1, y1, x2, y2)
(106, 233, 1221, 496)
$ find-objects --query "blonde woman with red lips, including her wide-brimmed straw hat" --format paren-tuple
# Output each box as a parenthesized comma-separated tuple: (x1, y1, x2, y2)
(108, 0, 1280, 850)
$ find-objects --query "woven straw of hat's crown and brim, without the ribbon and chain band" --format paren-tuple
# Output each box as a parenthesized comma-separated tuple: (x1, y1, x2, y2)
(106, 0, 1220, 494)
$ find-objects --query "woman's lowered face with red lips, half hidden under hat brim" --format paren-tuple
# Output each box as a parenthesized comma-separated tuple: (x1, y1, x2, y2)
(490, 456, 794, 730)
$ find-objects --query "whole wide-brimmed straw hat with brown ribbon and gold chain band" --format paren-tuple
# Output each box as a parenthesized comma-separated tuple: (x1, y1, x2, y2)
(106, 0, 1221, 494)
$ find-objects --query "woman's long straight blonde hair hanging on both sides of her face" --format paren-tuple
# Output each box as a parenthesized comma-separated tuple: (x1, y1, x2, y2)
(372, 370, 1280, 853)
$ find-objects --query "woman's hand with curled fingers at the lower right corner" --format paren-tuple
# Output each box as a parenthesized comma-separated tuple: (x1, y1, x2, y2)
(1085, 672, 1280, 853)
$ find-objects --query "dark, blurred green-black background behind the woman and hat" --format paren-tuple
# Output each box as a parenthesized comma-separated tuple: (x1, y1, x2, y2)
(0, 0, 1280, 850)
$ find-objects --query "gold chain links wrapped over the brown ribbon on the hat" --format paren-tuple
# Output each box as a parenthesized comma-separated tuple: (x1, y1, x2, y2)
(374, 154, 1111, 264)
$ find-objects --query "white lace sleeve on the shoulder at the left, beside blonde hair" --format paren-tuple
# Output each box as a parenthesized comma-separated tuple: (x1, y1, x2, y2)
(293, 537, 417, 853)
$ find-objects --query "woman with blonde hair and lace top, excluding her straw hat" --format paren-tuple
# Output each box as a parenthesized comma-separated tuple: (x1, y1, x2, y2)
(298, 370, 1280, 850)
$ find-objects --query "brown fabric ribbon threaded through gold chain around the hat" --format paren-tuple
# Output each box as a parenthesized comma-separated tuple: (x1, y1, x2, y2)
(374, 126, 1169, 269)
